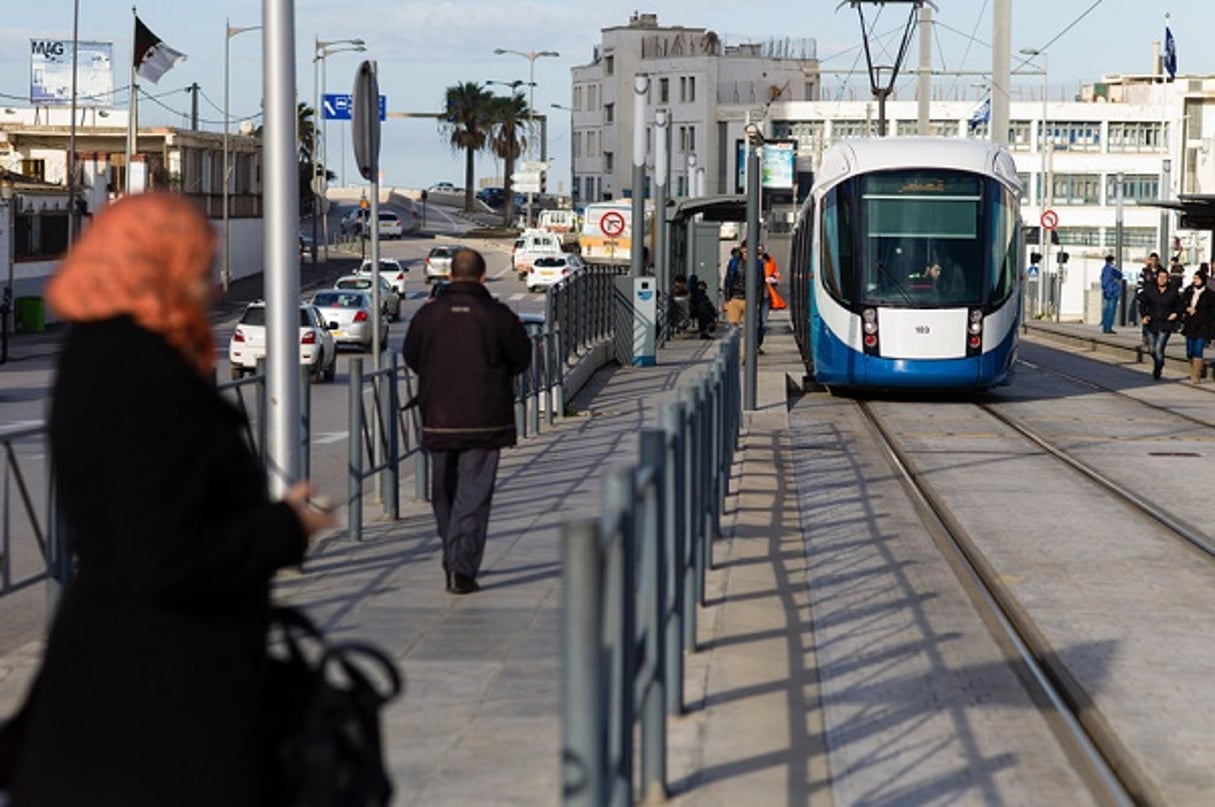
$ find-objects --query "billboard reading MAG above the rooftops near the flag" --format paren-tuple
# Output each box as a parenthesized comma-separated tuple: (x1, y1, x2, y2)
(29, 39, 114, 107)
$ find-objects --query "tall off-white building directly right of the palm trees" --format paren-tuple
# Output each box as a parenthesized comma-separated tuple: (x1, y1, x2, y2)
(571, 13, 818, 204)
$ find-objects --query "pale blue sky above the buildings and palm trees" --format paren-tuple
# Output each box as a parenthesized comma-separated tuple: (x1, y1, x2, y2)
(0, 0, 1200, 192)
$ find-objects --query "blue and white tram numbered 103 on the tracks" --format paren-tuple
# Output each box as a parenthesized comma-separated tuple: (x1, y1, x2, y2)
(790, 137, 1024, 389)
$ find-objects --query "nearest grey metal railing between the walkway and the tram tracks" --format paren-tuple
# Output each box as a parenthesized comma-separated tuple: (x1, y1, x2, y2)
(561, 329, 742, 807)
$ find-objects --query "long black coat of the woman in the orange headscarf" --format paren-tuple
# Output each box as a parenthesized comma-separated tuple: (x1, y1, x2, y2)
(2, 317, 305, 807)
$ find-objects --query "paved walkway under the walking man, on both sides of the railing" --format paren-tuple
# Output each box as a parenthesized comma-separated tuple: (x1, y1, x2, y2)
(267, 322, 808, 806)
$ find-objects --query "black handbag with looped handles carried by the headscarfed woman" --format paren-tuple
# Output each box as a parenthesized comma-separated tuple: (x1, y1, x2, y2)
(269, 606, 402, 807)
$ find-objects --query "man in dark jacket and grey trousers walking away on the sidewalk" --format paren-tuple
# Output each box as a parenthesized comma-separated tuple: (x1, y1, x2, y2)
(401, 249, 531, 594)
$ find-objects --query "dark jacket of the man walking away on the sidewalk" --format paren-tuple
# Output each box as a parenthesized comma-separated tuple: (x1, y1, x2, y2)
(401, 281, 531, 451)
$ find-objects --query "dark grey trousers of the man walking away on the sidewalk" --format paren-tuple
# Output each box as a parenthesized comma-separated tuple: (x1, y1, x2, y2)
(429, 448, 498, 580)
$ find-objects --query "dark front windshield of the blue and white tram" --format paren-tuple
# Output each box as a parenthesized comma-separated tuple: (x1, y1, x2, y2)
(824, 169, 1016, 307)
